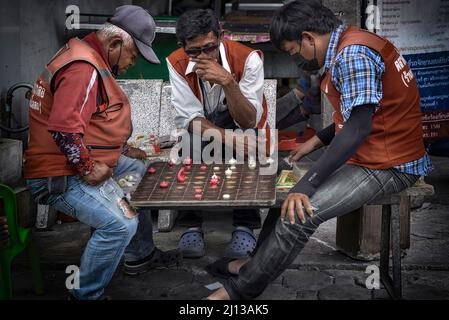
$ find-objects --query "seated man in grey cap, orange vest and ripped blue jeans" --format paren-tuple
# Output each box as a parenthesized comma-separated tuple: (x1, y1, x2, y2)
(25, 5, 178, 300)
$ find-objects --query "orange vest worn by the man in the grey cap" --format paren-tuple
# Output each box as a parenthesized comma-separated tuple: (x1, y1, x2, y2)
(24, 38, 132, 179)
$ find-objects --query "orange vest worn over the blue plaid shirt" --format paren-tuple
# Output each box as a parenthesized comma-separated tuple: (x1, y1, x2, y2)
(321, 27, 425, 169)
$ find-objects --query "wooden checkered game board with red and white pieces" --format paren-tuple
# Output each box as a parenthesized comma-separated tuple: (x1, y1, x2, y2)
(131, 162, 276, 209)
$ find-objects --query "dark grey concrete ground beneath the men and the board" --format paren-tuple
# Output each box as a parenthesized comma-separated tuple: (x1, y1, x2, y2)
(8, 157, 449, 300)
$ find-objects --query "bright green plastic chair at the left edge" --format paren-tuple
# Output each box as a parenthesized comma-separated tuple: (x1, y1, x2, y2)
(0, 184, 44, 300)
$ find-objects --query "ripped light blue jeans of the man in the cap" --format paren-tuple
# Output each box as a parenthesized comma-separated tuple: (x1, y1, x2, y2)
(27, 156, 155, 300)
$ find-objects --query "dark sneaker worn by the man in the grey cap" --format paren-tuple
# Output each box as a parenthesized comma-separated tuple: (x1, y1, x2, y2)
(124, 248, 182, 276)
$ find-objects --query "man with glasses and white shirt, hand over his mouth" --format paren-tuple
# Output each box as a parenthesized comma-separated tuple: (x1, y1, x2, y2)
(167, 9, 268, 259)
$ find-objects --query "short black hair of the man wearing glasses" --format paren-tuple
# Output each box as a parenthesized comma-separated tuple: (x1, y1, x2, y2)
(176, 9, 220, 46)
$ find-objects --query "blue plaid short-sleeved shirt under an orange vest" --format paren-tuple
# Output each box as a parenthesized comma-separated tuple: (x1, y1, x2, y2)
(324, 24, 433, 176)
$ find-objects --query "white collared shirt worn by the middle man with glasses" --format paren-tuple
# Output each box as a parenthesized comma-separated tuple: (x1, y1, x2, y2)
(167, 43, 264, 129)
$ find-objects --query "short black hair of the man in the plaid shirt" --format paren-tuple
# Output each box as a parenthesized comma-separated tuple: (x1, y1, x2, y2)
(270, 0, 342, 50)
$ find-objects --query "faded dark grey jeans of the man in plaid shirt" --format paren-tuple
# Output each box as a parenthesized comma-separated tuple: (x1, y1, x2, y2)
(224, 165, 419, 300)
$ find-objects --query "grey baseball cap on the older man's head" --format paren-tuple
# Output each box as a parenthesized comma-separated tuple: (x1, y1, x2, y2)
(108, 5, 161, 64)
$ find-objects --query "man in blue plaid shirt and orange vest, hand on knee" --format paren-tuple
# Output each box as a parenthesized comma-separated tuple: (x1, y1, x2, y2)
(209, 0, 432, 299)
